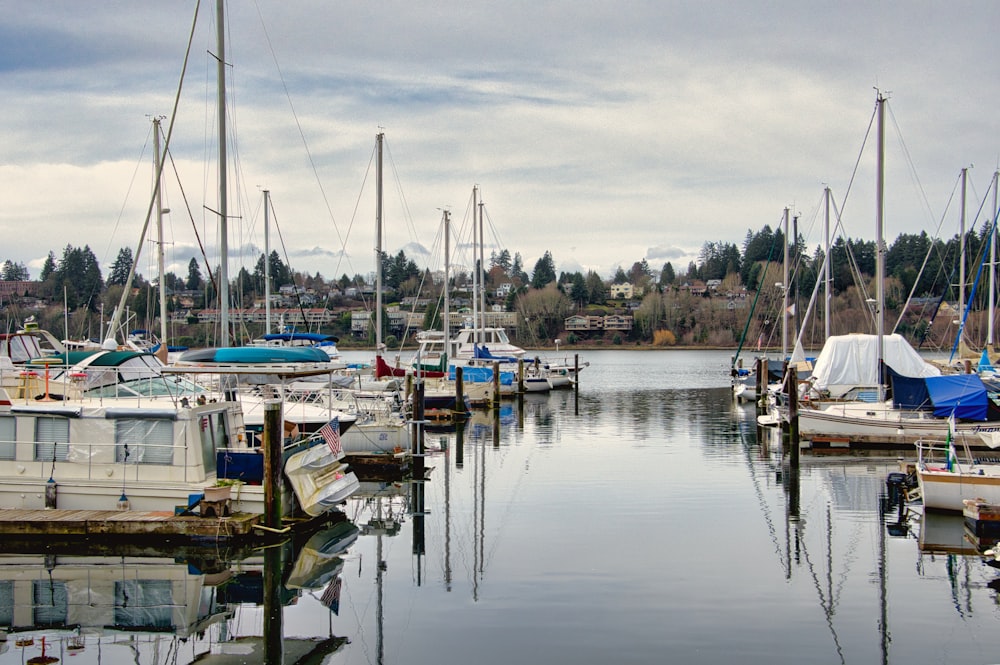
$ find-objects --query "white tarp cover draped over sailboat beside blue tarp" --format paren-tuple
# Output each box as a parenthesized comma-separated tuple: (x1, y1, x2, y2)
(812, 334, 941, 397)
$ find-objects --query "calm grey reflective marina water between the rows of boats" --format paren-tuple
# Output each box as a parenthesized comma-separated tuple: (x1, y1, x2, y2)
(0, 351, 1000, 665)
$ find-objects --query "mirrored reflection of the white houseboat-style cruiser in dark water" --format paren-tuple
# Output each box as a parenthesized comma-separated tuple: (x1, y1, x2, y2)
(0, 521, 359, 664)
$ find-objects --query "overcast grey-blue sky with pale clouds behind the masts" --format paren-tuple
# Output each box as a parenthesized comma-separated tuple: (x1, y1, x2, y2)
(0, 0, 1000, 278)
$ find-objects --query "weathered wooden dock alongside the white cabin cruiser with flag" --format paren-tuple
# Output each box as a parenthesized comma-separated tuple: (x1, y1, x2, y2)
(0, 509, 260, 550)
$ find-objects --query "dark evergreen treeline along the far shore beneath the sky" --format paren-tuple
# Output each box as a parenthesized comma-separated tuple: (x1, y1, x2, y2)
(0, 226, 988, 344)
